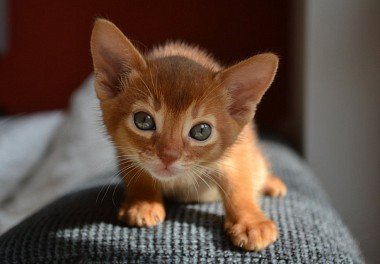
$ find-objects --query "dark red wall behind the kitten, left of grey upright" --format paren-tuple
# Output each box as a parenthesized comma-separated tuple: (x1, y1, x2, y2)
(0, 0, 289, 131)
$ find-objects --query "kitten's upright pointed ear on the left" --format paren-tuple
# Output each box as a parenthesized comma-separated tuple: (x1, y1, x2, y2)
(91, 19, 146, 100)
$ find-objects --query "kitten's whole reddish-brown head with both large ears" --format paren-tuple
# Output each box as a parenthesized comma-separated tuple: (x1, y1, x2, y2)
(91, 19, 278, 180)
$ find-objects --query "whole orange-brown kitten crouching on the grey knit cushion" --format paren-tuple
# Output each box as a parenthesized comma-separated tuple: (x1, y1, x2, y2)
(91, 19, 286, 250)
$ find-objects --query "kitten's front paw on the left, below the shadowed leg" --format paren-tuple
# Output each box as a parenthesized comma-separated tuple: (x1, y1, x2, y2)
(118, 201, 165, 227)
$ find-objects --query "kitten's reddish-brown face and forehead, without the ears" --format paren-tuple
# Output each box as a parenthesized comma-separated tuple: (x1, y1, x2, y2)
(103, 57, 238, 180)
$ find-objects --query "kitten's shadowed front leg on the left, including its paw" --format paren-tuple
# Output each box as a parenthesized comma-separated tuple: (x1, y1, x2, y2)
(118, 167, 165, 226)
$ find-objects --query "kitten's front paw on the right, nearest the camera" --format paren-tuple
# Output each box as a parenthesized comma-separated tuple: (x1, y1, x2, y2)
(224, 219, 277, 251)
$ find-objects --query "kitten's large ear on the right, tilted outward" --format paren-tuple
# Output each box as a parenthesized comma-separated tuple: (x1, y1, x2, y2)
(218, 53, 278, 123)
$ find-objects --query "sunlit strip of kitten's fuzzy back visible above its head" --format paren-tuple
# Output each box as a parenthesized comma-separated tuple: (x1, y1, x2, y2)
(146, 41, 222, 72)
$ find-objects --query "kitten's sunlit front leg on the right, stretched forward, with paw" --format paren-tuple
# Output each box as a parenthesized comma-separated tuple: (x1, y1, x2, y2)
(219, 157, 277, 251)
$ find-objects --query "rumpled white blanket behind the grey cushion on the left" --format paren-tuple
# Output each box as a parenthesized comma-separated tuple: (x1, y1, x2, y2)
(0, 76, 116, 233)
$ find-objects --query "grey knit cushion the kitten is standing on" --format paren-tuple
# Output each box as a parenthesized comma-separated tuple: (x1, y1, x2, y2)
(0, 142, 363, 263)
